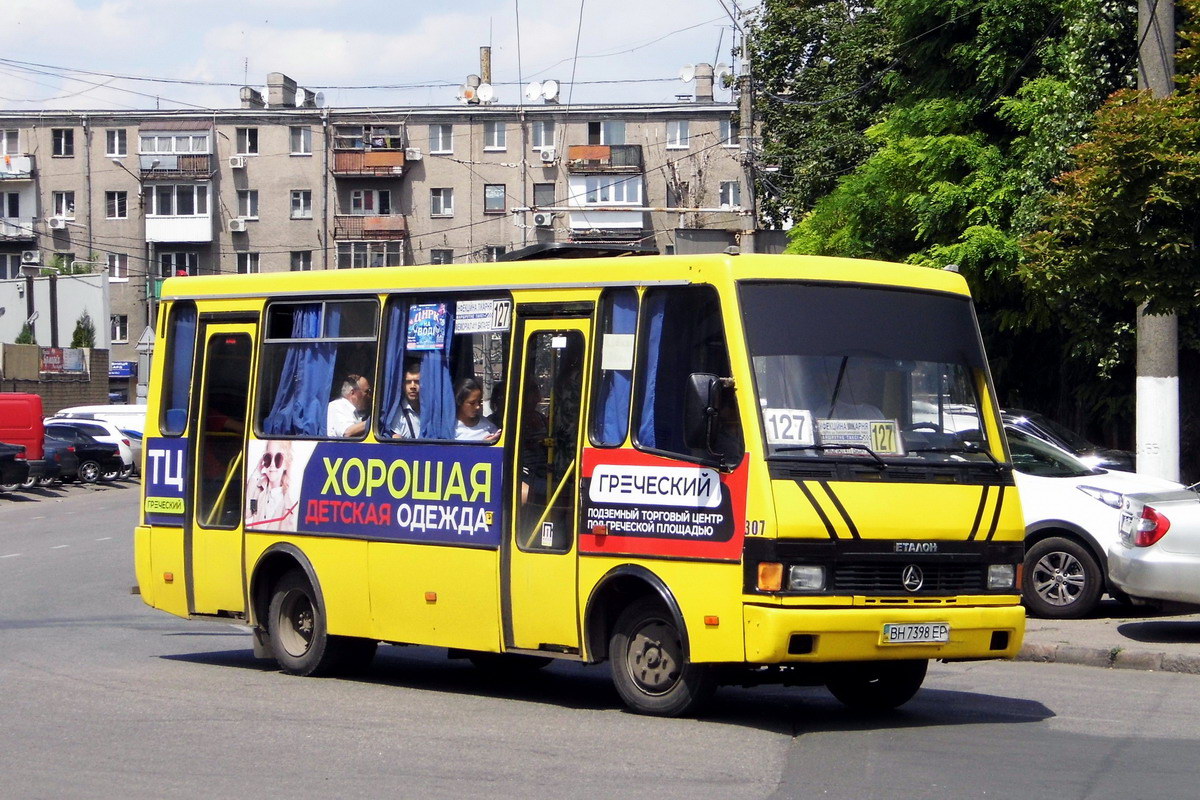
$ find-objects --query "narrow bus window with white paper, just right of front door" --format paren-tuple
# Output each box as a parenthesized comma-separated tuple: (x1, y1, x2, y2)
(592, 289, 637, 447)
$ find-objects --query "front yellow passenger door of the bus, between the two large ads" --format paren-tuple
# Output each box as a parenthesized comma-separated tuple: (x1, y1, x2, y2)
(504, 318, 590, 652)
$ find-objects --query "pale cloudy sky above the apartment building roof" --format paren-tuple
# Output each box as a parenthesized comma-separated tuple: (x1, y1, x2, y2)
(0, 0, 758, 110)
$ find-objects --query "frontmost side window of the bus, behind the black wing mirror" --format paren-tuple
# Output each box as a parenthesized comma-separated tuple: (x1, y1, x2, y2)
(636, 285, 744, 463)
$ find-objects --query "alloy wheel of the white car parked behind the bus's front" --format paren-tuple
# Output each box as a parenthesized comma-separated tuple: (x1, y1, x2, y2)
(1021, 536, 1104, 619)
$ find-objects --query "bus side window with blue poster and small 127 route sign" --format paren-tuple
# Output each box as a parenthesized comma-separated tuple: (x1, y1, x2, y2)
(376, 296, 512, 443)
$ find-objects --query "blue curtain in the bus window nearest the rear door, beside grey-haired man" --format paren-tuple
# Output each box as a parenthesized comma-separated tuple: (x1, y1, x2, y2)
(263, 303, 341, 437)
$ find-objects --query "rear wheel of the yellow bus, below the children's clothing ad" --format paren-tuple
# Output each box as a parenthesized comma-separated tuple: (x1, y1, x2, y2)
(266, 570, 348, 675)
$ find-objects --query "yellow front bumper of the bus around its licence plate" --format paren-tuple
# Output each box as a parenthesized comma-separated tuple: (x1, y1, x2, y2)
(743, 604, 1025, 664)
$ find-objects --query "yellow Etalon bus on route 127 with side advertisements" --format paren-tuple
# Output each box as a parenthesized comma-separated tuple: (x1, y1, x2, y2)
(134, 254, 1025, 715)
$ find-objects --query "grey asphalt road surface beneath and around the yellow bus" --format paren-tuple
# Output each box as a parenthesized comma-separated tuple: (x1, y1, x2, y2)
(0, 483, 1200, 800)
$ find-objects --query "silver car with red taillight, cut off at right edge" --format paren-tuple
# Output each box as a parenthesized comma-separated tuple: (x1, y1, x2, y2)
(1109, 488, 1200, 604)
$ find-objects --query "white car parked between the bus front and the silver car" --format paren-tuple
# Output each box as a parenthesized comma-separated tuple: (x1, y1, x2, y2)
(1004, 426, 1183, 619)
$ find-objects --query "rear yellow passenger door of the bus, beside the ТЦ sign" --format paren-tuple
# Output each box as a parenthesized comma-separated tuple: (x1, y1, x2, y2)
(186, 317, 254, 614)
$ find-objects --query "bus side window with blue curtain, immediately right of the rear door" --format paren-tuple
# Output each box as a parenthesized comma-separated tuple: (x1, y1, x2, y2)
(257, 300, 379, 438)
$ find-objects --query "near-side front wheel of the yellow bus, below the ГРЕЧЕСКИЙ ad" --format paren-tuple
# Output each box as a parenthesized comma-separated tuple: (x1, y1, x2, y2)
(608, 599, 716, 717)
